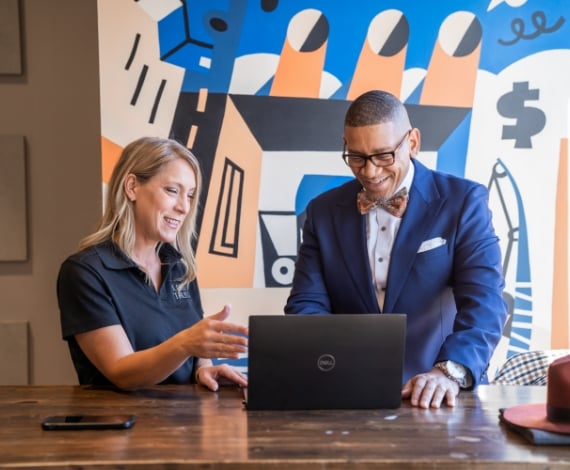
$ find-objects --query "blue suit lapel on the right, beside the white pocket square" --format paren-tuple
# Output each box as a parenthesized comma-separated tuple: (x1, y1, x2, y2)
(383, 160, 446, 312)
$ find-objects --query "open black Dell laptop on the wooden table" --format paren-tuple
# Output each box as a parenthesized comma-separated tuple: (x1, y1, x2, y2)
(244, 313, 406, 410)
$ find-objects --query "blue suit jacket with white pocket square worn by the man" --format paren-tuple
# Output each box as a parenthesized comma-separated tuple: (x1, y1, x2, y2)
(285, 160, 507, 386)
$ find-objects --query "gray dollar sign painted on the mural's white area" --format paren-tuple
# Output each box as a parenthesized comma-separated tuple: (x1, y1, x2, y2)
(497, 82, 546, 148)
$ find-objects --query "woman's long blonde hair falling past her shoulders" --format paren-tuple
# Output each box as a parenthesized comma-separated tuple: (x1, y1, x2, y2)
(79, 137, 202, 288)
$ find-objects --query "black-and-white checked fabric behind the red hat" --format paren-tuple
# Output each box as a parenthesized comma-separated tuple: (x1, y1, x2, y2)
(491, 349, 570, 385)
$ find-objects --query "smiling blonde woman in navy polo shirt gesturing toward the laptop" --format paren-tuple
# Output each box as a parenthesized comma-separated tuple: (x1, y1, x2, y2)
(57, 137, 247, 390)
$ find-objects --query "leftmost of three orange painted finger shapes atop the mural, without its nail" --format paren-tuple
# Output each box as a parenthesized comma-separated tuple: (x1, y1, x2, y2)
(269, 40, 328, 98)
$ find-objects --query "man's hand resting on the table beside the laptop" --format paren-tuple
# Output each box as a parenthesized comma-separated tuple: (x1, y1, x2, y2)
(402, 368, 459, 408)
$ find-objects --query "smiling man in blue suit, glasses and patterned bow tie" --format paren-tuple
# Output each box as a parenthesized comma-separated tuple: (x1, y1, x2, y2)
(285, 91, 507, 408)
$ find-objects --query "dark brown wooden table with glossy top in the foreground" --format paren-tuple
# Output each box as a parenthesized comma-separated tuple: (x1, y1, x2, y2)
(0, 385, 570, 470)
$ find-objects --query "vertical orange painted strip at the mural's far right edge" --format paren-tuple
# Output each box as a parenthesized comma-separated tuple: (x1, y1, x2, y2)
(550, 139, 570, 349)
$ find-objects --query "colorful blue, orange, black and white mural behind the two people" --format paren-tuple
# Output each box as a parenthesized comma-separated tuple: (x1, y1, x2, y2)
(98, 0, 570, 374)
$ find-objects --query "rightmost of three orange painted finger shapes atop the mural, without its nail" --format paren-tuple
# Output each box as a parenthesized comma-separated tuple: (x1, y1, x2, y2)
(420, 43, 481, 108)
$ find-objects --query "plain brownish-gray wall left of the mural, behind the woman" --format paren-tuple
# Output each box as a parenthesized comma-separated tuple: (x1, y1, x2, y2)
(0, 0, 101, 384)
